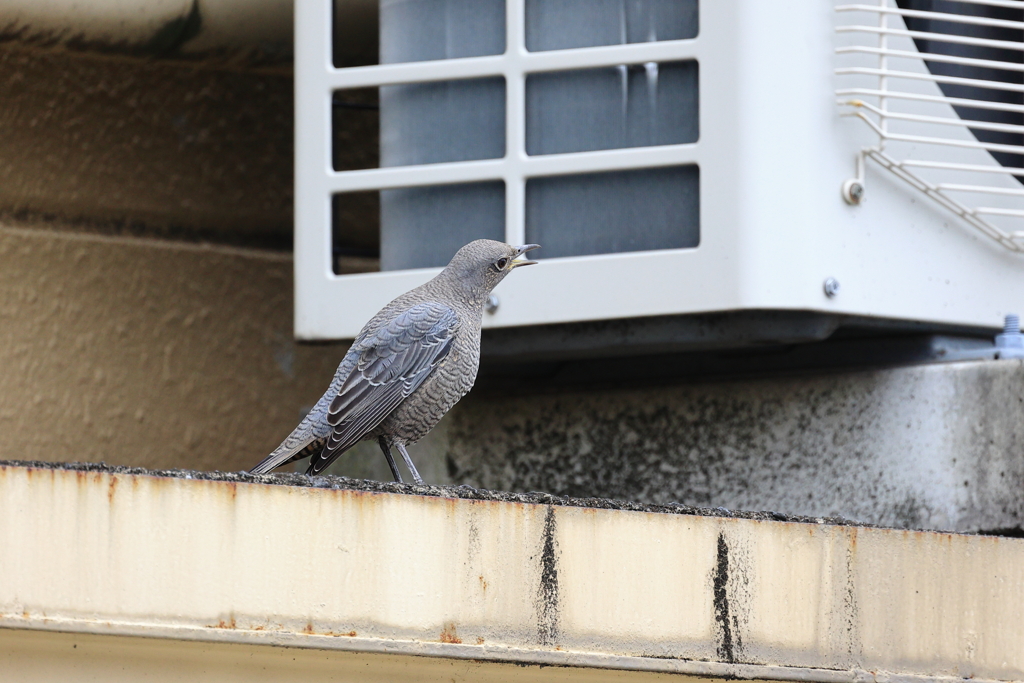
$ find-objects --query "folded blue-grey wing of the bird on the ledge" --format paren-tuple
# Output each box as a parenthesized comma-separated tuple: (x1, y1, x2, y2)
(307, 302, 459, 474)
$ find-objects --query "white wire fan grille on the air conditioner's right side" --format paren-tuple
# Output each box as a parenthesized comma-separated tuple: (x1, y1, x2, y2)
(836, 0, 1024, 252)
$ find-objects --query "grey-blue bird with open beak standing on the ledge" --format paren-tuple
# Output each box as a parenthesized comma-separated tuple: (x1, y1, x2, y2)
(249, 240, 540, 485)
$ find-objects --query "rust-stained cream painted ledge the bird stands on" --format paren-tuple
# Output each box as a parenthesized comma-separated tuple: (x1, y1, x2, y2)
(0, 466, 1024, 681)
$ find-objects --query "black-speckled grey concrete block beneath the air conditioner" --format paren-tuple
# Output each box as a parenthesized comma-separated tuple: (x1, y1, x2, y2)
(442, 360, 1024, 530)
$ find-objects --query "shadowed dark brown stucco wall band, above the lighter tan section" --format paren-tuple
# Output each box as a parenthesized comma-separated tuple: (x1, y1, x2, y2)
(0, 45, 293, 248)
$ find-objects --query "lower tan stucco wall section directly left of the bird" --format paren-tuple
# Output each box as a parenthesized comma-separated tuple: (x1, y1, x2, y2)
(0, 226, 348, 473)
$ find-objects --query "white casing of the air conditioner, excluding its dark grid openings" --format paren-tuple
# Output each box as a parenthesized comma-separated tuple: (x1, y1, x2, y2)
(295, 0, 1024, 339)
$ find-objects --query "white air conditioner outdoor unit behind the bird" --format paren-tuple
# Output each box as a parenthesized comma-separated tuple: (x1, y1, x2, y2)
(295, 0, 1024, 339)
